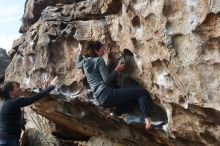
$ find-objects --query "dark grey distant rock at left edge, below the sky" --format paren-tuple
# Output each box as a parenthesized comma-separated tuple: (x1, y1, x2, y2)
(0, 48, 11, 82)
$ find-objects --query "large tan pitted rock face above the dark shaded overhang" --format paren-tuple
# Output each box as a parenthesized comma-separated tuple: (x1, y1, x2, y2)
(6, 0, 220, 145)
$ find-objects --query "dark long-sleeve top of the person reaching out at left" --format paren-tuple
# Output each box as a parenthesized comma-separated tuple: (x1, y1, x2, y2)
(0, 86, 55, 136)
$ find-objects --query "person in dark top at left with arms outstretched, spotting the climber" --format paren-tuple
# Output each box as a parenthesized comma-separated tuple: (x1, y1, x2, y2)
(0, 77, 58, 146)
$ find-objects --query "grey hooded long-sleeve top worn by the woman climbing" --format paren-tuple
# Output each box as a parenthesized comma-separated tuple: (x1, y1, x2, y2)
(76, 55, 117, 98)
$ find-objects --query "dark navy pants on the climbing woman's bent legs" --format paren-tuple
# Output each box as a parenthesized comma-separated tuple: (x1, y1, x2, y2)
(98, 87, 151, 117)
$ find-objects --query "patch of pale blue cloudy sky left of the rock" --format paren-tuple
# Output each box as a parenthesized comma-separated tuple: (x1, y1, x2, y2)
(0, 0, 25, 51)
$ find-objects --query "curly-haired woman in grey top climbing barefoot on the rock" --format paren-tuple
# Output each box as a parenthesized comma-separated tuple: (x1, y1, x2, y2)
(76, 42, 155, 129)
